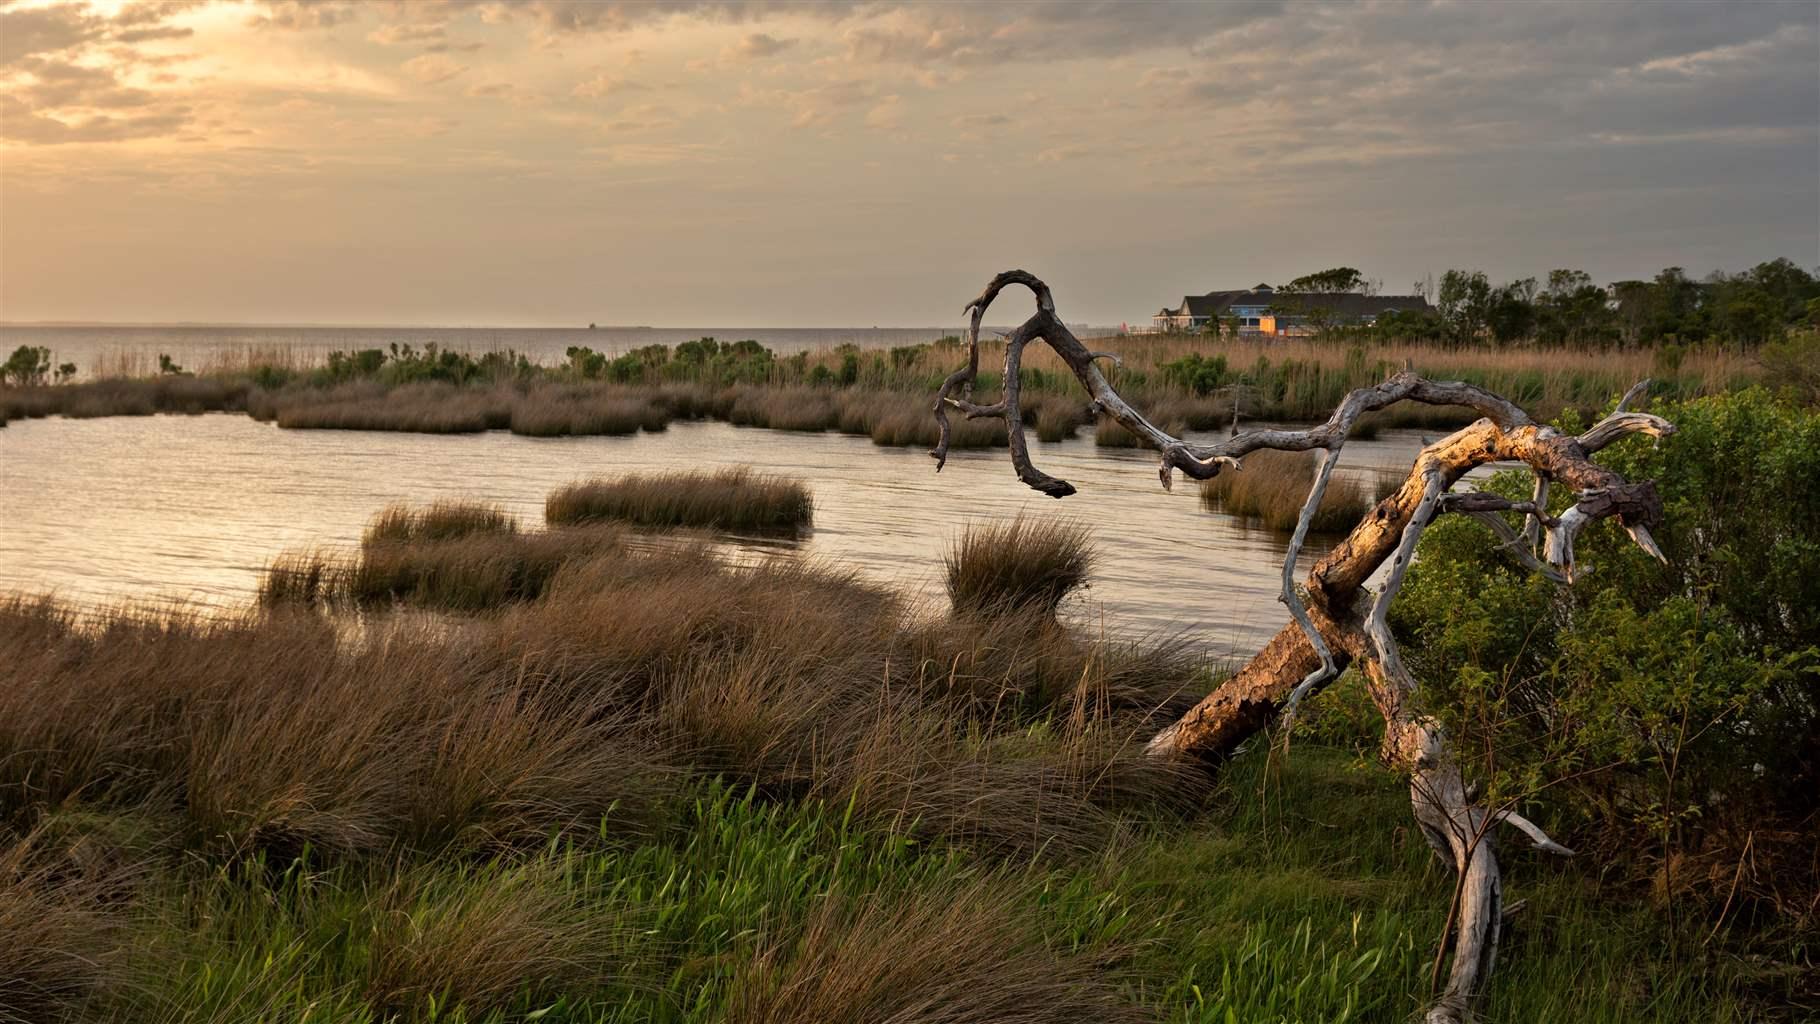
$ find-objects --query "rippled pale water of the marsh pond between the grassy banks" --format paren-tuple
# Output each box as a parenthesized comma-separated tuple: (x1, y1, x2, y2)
(0, 415, 1448, 655)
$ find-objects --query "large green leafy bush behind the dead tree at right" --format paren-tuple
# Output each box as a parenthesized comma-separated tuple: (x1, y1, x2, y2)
(1392, 389, 1820, 897)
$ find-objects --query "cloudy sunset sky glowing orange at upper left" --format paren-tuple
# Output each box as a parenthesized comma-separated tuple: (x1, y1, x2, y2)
(0, 0, 1820, 326)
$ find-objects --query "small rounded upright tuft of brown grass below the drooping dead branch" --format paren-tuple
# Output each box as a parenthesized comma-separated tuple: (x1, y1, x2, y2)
(943, 515, 1094, 615)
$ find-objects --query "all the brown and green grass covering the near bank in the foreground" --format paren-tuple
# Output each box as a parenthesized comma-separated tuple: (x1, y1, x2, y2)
(0, 482, 1776, 1024)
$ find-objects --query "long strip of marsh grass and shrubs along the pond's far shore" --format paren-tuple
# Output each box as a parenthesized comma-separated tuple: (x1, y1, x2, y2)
(0, 331, 1798, 447)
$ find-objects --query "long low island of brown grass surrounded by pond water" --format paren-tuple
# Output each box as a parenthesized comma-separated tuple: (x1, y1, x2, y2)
(544, 466, 815, 533)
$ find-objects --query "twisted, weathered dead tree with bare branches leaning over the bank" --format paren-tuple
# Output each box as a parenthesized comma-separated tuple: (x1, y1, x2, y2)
(930, 271, 1674, 1024)
